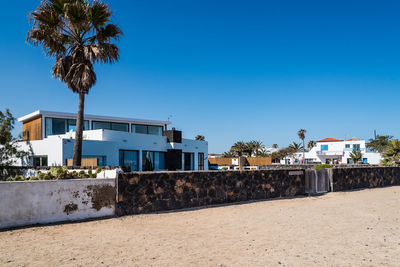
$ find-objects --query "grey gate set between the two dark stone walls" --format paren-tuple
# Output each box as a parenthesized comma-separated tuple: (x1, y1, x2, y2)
(305, 169, 332, 194)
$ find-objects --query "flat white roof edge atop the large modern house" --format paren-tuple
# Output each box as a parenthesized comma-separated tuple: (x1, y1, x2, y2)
(18, 110, 171, 125)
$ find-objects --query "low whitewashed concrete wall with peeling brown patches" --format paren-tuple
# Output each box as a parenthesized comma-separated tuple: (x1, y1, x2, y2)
(0, 179, 116, 228)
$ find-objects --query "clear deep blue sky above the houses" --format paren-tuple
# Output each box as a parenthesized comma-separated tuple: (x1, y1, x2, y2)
(0, 0, 400, 153)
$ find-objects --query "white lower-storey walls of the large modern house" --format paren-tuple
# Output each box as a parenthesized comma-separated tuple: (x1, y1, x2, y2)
(18, 130, 208, 170)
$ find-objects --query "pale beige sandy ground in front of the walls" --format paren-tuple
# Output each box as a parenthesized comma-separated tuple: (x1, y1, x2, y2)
(0, 186, 400, 266)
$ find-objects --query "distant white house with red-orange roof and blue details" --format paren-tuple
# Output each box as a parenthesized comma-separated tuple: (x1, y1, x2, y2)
(281, 138, 382, 164)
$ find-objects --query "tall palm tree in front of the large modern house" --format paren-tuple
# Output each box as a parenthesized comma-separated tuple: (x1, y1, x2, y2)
(27, 0, 122, 166)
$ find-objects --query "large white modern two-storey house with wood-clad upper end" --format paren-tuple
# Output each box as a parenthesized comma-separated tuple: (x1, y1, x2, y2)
(18, 110, 208, 171)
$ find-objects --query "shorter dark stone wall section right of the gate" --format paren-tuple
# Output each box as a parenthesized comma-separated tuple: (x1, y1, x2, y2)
(332, 167, 400, 191)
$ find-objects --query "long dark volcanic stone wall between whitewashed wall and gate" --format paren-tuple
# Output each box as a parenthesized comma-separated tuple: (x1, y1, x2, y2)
(116, 170, 305, 215)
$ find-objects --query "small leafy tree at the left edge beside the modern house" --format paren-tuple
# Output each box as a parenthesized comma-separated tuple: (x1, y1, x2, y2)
(0, 109, 29, 180)
